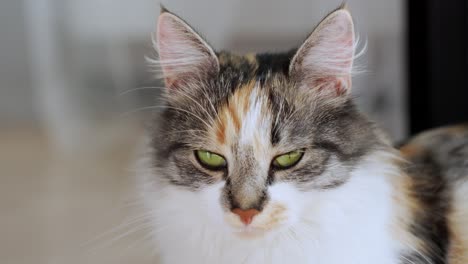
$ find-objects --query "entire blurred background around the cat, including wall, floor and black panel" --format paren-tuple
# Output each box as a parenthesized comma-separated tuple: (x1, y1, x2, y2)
(0, 0, 468, 264)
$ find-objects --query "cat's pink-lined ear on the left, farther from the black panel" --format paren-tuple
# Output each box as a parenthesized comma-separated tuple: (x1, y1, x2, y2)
(156, 9, 219, 89)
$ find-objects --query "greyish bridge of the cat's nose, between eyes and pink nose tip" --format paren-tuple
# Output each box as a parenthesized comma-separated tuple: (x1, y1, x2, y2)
(226, 147, 268, 210)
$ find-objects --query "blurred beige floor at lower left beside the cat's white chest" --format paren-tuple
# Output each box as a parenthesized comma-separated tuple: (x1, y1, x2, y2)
(0, 125, 154, 264)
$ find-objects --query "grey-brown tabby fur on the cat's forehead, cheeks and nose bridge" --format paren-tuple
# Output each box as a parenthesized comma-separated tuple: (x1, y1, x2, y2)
(152, 8, 385, 213)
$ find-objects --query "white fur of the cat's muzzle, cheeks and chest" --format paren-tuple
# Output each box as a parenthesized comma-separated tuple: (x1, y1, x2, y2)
(144, 153, 406, 264)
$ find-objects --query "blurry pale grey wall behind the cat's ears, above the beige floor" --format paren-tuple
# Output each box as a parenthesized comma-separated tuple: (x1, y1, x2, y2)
(0, 0, 406, 151)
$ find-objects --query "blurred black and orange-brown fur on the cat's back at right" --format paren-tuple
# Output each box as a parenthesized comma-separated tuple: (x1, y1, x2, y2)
(400, 124, 468, 264)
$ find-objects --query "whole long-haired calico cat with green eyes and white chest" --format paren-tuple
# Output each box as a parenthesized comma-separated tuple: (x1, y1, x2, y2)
(141, 8, 468, 264)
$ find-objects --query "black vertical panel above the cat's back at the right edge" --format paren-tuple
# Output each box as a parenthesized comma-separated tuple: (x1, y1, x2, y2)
(407, 0, 468, 134)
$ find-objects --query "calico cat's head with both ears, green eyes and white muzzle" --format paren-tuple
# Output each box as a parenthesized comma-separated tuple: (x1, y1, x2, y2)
(150, 9, 379, 237)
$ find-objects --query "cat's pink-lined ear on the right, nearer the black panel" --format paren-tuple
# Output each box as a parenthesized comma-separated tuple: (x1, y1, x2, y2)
(289, 9, 355, 95)
